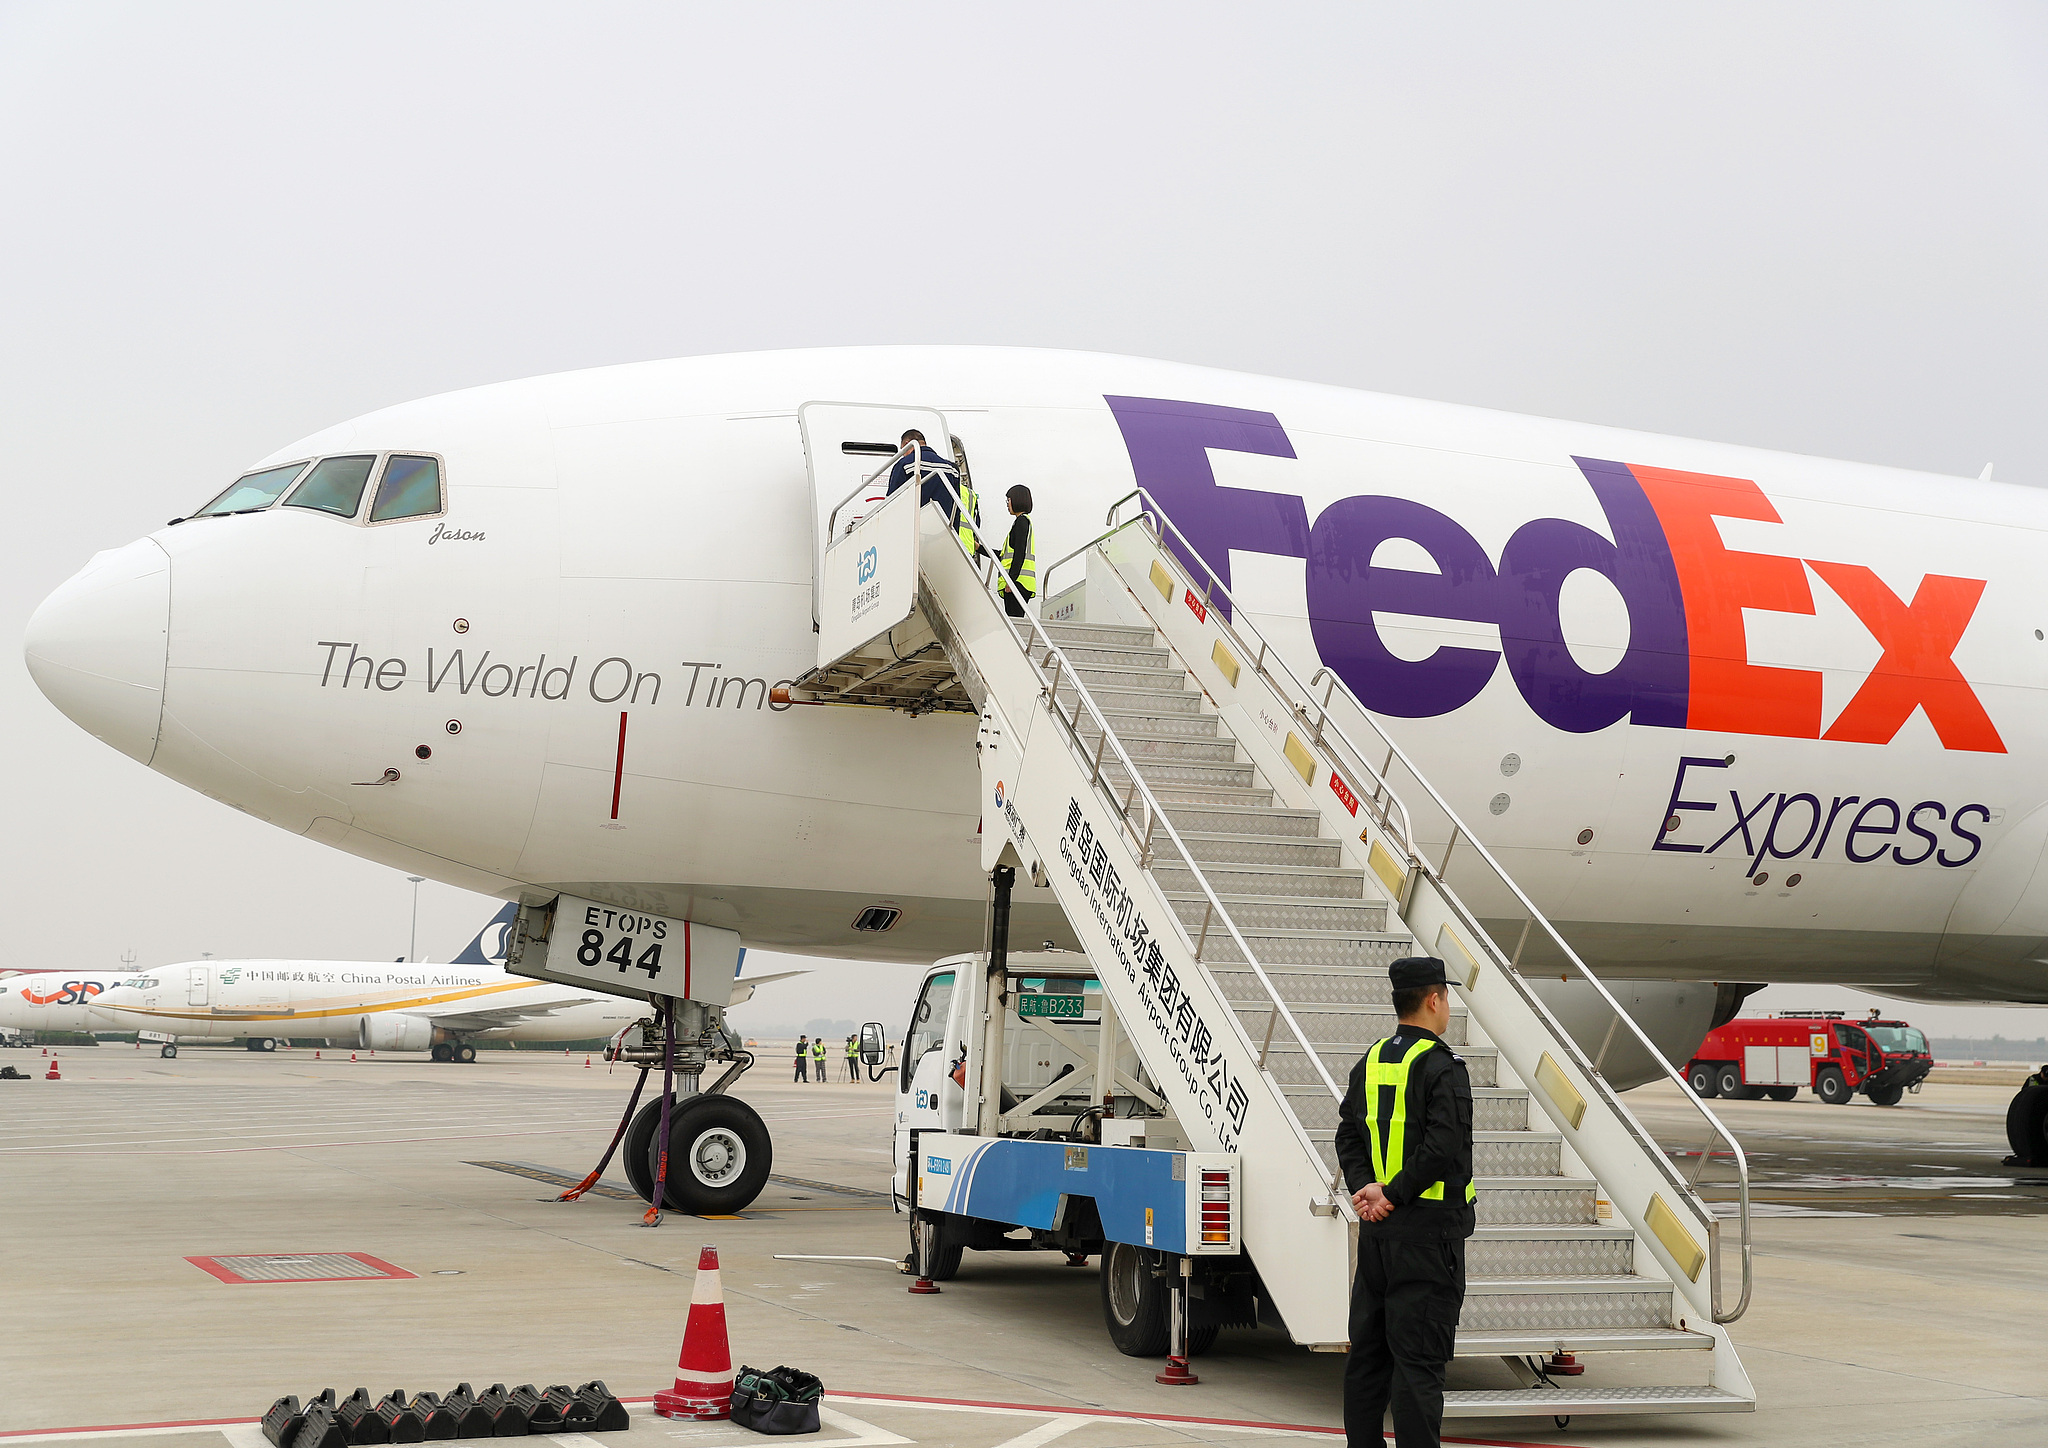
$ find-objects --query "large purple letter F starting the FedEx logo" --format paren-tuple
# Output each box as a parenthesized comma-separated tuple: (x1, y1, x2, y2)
(1104, 397, 1309, 619)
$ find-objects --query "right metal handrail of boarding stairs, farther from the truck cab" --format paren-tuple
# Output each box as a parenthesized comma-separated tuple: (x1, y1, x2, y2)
(1044, 487, 1753, 1323)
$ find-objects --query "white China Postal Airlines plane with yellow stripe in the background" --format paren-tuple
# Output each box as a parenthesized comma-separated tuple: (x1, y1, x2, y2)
(90, 905, 639, 1061)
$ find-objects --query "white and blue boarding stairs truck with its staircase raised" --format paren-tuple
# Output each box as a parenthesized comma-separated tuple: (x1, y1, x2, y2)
(788, 403, 1755, 1417)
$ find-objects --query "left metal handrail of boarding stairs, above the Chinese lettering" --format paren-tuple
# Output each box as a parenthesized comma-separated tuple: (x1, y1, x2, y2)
(909, 477, 1358, 1221)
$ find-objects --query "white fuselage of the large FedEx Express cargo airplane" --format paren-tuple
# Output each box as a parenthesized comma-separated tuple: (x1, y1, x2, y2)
(27, 346, 2048, 1146)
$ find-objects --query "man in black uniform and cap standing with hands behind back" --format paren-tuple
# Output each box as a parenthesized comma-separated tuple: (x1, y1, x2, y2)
(1337, 956, 1475, 1448)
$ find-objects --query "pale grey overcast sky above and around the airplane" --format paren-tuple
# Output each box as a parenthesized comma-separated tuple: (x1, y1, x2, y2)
(0, 0, 2048, 1036)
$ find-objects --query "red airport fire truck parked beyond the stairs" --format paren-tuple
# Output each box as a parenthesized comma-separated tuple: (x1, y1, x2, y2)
(1686, 1010, 1933, 1106)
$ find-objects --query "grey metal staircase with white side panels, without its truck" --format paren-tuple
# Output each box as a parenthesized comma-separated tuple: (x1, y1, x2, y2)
(801, 423, 1753, 1417)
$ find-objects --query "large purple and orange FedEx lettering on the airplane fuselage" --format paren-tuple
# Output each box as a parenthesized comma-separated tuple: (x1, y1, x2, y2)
(1108, 397, 2005, 754)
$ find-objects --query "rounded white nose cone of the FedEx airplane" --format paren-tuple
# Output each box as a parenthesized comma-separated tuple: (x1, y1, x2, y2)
(23, 539, 170, 764)
